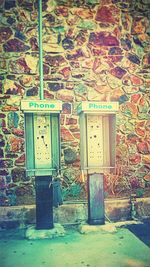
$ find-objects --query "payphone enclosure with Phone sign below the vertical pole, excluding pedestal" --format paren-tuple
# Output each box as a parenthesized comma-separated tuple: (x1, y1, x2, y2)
(21, 100, 62, 176)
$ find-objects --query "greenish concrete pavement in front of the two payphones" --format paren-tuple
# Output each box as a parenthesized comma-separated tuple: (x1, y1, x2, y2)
(0, 224, 150, 267)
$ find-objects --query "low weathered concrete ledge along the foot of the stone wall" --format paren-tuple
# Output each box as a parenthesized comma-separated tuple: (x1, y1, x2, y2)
(0, 198, 150, 230)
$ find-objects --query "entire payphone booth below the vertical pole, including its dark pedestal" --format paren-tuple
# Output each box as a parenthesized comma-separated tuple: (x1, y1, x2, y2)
(21, 100, 62, 229)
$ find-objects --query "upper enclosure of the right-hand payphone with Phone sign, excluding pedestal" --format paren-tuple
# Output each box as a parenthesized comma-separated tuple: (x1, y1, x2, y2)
(78, 102, 118, 173)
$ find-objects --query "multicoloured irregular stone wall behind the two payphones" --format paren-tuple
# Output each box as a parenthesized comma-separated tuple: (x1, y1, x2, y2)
(0, 0, 150, 205)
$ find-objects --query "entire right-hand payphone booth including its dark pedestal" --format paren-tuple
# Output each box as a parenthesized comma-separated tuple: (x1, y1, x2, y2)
(78, 101, 118, 225)
